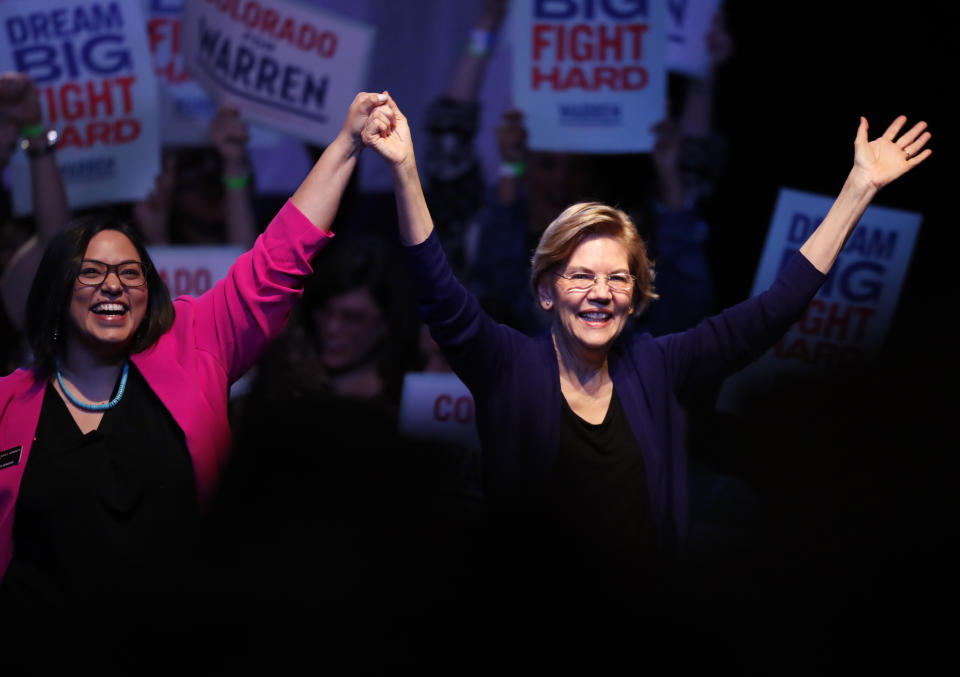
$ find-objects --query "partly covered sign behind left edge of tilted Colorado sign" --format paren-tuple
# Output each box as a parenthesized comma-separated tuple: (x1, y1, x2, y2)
(147, 0, 217, 146)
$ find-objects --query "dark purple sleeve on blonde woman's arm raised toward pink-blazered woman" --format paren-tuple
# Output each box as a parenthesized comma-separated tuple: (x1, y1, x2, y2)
(406, 230, 529, 394)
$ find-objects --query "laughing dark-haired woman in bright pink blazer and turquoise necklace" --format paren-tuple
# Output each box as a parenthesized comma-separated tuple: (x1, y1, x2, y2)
(0, 88, 385, 660)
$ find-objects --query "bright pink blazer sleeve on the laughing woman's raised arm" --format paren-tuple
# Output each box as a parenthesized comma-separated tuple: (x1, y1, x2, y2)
(188, 200, 332, 383)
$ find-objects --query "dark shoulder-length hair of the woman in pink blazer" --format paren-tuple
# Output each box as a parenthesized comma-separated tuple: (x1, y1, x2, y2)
(26, 213, 174, 374)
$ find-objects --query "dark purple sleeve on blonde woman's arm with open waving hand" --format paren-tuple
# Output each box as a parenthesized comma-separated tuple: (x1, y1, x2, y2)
(655, 252, 826, 396)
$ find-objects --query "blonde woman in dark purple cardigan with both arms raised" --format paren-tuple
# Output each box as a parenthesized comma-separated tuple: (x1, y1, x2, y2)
(362, 93, 931, 666)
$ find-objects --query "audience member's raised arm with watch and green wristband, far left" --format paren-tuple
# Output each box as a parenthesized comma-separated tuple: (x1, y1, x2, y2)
(0, 73, 70, 330)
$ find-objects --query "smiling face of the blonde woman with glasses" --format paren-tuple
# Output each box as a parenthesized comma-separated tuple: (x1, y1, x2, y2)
(539, 235, 633, 362)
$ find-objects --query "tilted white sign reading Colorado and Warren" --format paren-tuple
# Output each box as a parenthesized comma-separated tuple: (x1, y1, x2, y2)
(181, 0, 374, 144)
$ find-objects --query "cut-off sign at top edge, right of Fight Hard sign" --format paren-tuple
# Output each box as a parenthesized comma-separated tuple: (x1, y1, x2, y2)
(667, 0, 720, 77)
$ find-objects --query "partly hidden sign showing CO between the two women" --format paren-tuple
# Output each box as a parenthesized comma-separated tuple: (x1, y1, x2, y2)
(400, 372, 480, 450)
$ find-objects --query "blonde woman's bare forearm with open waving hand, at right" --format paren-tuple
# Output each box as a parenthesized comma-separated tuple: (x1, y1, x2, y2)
(800, 115, 932, 273)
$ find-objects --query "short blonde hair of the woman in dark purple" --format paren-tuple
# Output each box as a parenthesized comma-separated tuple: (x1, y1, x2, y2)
(530, 202, 657, 313)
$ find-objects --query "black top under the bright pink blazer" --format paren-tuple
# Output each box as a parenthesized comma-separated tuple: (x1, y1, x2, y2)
(0, 364, 198, 617)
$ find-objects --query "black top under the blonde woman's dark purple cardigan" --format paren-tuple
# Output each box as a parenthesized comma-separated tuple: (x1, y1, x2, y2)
(548, 391, 656, 595)
